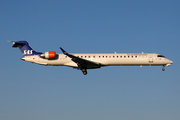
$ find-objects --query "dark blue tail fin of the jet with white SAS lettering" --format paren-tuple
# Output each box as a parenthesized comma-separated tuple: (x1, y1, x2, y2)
(9, 41, 42, 56)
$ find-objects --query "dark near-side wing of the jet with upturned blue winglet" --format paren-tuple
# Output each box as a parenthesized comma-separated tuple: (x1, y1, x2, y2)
(60, 47, 101, 69)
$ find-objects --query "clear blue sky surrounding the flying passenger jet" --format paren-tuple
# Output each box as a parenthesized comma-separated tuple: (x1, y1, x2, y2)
(0, 0, 180, 120)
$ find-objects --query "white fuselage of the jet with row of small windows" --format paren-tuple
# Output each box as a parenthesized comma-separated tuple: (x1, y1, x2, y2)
(21, 53, 173, 68)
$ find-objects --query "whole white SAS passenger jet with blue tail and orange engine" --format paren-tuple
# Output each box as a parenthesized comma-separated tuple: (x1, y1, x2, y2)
(8, 41, 173, 75)
